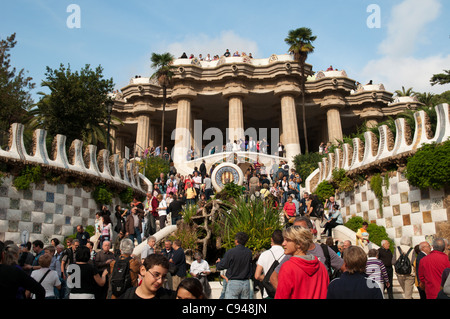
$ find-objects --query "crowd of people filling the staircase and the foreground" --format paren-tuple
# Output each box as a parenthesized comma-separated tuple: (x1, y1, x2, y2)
(0, 157, 450, 299)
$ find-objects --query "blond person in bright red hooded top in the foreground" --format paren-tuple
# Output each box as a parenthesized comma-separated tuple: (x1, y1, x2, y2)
(275, 226, 330, 299)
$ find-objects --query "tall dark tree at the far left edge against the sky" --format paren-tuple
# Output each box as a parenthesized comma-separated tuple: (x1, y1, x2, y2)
(0, 33, 35, 144)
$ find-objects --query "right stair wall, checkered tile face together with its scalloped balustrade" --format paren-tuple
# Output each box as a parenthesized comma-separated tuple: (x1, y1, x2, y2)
(305, 104, 450, 244)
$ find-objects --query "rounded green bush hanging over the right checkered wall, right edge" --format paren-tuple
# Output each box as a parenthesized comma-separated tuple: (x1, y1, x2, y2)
(406, 140, 450, 190)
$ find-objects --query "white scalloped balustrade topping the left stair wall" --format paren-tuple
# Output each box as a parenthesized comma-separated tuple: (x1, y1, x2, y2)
(0, 123, 147, 193)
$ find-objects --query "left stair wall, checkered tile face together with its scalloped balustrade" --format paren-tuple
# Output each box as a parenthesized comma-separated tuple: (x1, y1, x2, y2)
(0, 124, 152, 243)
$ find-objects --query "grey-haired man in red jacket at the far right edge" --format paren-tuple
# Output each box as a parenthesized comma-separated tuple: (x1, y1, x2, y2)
(419, 238, 450, 299)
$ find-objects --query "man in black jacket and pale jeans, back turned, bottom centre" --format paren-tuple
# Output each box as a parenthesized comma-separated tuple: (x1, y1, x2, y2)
(216, 232, 252, 299)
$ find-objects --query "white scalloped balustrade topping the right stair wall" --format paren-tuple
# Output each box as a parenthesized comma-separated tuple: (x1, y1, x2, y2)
(305, 103, 450, 192)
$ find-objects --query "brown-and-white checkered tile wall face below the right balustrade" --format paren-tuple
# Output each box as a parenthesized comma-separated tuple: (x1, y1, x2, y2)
(336, 173, 450, 245)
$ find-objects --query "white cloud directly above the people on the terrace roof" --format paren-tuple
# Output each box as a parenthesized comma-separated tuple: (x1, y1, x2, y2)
(161, 31, 258, 57)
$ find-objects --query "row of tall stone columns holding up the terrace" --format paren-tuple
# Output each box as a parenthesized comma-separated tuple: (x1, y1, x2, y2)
(115, 85, 343, 162)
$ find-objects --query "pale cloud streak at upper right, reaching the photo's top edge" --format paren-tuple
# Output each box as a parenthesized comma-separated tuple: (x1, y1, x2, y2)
(379, 0, 441, 56)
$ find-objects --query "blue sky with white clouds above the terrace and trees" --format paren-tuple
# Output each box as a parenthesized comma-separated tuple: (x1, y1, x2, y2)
(0, 0, 450, 99)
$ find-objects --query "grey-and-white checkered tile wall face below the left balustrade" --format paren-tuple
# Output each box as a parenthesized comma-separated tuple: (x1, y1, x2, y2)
(0, 177, 120, 243)
